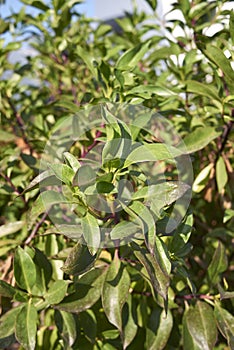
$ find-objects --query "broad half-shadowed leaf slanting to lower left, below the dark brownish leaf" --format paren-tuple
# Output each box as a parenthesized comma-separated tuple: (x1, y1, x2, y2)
(54, 268, 106, 313)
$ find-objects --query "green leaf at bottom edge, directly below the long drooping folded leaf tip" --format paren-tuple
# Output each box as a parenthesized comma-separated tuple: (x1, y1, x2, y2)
(145, 307, 173, 350)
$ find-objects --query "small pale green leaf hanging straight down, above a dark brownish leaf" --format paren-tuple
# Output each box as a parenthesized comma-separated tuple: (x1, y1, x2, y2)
(81, 213, 101, 255)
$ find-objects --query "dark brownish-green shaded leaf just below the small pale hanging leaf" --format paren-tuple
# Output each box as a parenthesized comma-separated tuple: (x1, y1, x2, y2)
(62, 243, 97, 275)
